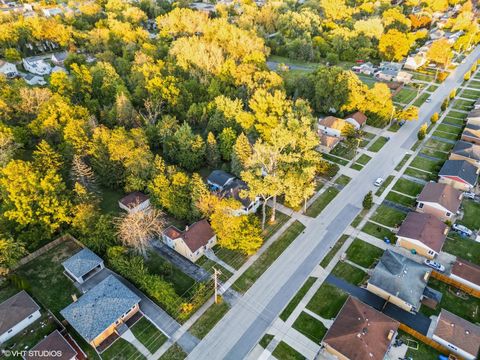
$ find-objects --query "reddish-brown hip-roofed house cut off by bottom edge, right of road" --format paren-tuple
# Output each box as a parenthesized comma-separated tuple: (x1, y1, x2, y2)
(322, 297, 400, 360)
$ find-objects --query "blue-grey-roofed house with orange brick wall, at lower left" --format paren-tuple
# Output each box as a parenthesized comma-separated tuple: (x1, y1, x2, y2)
(60, 275, 140, 348)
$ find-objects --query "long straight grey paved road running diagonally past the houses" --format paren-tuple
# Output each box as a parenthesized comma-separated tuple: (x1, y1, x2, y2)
(188, 47, 480, 360)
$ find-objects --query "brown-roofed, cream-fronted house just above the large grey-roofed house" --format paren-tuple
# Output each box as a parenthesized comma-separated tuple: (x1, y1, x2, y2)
(397, 211, 449, 259)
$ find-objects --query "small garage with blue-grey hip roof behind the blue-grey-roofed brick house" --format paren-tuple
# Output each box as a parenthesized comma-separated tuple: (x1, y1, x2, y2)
(62, 248, 105, 284)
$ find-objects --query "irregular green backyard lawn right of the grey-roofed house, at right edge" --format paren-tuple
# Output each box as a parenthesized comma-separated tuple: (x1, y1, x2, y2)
(420, 278, 480, 324)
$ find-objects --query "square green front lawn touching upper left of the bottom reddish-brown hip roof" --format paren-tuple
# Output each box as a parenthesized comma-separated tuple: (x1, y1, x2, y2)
(307, 283, 348, 319)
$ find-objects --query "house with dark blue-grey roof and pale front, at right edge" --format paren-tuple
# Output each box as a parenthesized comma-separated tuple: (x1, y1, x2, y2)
(438, 160, 479, 191)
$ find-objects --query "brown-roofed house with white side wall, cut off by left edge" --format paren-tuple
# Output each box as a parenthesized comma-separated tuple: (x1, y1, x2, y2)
(0, 290, 41, 344)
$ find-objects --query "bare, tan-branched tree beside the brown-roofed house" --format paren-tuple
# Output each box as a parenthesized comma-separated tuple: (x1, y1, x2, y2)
(116, 209, 164, 256)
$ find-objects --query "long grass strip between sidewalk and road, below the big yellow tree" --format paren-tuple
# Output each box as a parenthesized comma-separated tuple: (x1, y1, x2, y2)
(233, 221, 305, 292)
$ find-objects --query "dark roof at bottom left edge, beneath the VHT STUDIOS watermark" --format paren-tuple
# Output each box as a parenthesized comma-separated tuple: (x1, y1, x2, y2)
(23, 330, 78, 360)
